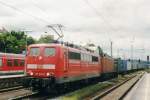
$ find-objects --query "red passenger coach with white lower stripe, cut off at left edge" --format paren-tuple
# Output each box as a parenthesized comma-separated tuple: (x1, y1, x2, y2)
(0, 53, 25, 88)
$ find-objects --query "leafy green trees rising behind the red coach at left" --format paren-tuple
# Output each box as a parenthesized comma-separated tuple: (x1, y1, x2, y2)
(0, 31, 36, 53)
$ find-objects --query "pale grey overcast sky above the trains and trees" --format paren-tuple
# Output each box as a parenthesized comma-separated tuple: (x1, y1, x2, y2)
(0, 0, 150, 59)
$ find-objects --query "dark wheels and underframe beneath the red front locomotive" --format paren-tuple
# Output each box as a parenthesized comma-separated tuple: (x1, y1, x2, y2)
(24, 74, 100, 91)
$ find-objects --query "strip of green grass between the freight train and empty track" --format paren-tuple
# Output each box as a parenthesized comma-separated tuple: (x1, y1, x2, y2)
(61, 74, 138, 100)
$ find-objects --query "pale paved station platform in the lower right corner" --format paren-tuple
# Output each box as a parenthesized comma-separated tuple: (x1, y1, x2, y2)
(123, 73, 150, 100)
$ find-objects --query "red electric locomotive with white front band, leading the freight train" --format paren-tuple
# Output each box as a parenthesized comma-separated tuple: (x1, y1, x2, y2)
(25, 44, 101, 90)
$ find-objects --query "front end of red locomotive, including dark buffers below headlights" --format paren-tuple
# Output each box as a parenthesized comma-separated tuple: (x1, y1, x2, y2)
(24, 44, 59, 87)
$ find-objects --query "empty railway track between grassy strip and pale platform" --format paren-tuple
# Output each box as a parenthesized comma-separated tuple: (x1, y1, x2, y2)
(90, 73, 143, 100)
